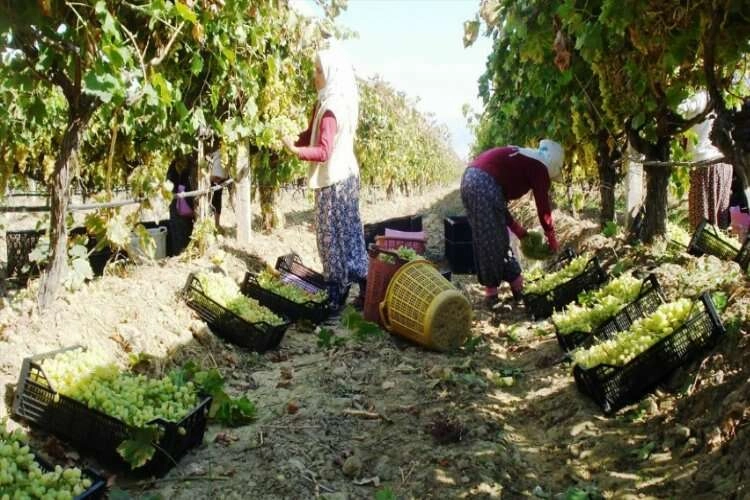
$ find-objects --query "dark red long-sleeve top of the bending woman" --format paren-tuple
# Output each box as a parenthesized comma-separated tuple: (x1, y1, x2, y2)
(469, 146, 554, 233)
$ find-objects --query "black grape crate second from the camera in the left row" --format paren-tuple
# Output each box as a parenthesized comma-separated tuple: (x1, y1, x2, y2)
(182, 273, 289, 352)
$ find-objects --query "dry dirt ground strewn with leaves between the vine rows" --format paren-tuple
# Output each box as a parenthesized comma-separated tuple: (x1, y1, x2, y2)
(0, 182, 750, 500)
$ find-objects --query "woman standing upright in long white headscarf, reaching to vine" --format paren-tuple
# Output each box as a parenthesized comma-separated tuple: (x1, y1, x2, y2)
(284, 47, 367, 307)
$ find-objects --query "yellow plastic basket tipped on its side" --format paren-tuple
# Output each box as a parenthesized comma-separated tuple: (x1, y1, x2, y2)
(380, 260, 471, 351)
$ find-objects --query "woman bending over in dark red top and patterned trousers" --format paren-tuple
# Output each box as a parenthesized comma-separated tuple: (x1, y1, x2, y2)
(461, 139, 563, 307)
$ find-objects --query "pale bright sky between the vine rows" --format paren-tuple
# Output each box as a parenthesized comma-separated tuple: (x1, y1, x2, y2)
(295, 0, 491, 159)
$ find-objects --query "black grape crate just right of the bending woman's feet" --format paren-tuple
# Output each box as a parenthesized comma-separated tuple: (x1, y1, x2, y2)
(523, 257, 609, 319)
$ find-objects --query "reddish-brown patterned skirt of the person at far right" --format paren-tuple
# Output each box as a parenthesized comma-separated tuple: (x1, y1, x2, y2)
(688, 163, 732, 229)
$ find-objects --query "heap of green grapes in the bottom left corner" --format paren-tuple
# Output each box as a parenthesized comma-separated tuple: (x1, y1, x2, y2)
(0, 420, 91, 500)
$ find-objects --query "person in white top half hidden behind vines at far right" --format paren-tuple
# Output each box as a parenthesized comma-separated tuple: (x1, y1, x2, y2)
(677, 90, 733, 230)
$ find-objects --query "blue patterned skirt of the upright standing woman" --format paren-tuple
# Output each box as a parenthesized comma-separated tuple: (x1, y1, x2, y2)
(315, 176, 367, 287)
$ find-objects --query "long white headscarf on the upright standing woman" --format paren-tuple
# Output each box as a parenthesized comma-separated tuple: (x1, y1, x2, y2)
(312, 46, 359, 144)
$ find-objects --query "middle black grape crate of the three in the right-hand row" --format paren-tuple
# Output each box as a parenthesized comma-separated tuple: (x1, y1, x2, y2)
(555, 274, 664, 351)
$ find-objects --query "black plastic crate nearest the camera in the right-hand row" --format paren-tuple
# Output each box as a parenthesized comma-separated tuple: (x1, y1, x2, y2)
(573, 292, 726, 414)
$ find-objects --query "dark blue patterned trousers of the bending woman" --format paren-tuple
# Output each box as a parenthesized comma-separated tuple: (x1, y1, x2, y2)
(461, 167, 521, 287)
